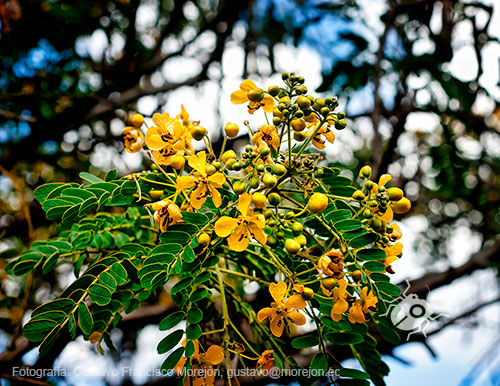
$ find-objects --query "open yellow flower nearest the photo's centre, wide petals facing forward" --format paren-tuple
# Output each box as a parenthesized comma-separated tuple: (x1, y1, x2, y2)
(214, 193, 267, 252)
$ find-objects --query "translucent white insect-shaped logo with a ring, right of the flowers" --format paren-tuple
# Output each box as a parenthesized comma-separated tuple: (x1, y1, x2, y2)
(382, 280, 448, 341)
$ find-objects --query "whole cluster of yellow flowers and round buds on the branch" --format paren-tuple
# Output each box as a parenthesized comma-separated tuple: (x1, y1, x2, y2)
(124, 73, 411, 385)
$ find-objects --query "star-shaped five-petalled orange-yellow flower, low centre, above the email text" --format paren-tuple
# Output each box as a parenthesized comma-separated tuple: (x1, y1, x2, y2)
(257, 281, 306, 338)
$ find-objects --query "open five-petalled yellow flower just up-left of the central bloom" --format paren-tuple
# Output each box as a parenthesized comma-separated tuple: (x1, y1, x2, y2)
(175, 151, 226, 209)
